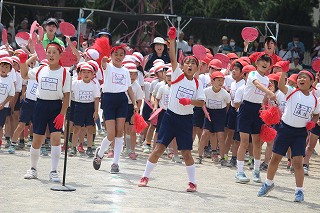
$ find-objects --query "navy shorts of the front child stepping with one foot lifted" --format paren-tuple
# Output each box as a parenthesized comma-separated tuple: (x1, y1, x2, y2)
(102, 92, 128, 121)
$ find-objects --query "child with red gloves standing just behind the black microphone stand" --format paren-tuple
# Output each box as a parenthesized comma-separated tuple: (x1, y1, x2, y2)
(19, 42, 70, 182)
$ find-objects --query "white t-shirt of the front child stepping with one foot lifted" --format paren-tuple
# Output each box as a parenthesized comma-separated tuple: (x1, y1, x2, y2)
(102, 62, 131, 93)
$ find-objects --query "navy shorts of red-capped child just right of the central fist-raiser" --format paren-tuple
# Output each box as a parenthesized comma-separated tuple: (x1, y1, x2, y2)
(203, 108, 227, 133)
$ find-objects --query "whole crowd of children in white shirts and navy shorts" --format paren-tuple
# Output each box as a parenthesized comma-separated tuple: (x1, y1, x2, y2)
(0, 18, 320, 202)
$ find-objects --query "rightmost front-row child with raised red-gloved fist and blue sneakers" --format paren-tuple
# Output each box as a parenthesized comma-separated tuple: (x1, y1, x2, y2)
(258, 67, 319, 202)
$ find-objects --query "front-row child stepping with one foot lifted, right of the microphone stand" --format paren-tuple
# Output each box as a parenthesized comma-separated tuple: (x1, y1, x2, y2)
(93, 45, 138, 174)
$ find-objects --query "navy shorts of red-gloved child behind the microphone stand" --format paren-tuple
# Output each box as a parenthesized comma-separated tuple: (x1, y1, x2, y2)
(32, 99, 62, 135)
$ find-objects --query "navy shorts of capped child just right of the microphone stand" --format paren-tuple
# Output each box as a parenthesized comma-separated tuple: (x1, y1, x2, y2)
(73, 102, 95, 127)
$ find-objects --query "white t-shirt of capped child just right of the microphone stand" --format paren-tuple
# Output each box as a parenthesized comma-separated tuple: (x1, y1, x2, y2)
(72, 80, 100, 103)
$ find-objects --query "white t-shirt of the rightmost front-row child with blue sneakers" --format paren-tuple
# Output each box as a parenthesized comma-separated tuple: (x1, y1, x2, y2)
(281, 86, 320, 128)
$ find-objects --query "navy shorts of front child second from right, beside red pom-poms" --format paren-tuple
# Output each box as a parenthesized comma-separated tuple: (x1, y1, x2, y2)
(237, 101, 263, 134)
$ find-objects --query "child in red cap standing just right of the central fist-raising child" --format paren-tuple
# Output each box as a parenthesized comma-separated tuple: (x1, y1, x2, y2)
(197, 72, 231, 166)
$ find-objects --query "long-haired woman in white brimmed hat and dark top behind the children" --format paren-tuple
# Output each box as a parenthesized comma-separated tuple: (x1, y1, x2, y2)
(144, 37, 170, 70)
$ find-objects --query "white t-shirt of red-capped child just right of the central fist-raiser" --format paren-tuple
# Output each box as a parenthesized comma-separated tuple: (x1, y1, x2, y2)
(203, 87, 231, 109)
